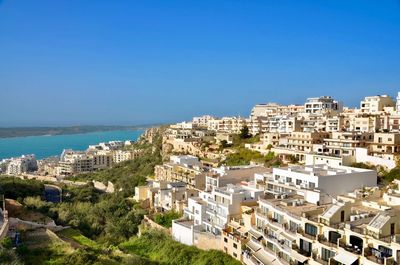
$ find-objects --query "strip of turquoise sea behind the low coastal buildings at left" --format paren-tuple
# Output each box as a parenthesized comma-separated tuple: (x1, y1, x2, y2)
(0, 130, 144, 159)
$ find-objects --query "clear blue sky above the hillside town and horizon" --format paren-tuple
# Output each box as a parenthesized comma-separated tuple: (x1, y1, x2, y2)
(0, 0, 400, 126)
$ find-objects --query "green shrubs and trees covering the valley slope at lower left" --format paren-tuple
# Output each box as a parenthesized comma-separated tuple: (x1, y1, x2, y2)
(0, 127, 240, 265)
